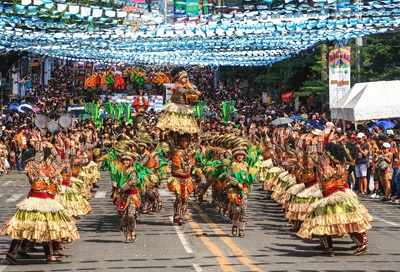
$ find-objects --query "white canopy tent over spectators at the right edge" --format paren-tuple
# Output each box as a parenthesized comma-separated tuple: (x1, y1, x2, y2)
(332, 80, 400, 122)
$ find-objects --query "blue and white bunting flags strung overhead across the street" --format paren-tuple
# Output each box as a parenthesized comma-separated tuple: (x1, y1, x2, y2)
(0, 0, 400, 66)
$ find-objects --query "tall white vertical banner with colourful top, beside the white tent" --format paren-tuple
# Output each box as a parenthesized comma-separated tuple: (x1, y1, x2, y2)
(328, 46, 351, 108)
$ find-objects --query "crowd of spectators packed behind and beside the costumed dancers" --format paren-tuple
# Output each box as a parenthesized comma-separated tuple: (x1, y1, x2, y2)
(0, 60, 400, 201)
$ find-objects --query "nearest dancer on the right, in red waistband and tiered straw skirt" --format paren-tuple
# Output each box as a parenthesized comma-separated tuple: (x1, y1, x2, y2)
(297, 143, 372, 257)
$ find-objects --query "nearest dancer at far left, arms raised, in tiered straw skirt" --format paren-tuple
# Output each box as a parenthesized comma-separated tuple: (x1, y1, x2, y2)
(1, 131, 79, 264)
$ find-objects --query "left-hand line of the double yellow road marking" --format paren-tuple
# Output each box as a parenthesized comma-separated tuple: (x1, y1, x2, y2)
(186, 214, 235, 271)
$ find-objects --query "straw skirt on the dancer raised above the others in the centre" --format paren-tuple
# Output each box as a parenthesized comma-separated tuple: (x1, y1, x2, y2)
(156, 103, 200, 134)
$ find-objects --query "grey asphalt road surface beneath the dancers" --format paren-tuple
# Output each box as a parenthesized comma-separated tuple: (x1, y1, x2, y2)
(0, 172, 400, 272)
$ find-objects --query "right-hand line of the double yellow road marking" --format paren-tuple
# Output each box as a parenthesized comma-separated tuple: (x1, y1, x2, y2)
(190, 201, 263, 272)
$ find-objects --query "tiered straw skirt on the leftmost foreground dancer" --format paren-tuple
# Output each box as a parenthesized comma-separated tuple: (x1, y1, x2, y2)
(0, 197, 79, 242)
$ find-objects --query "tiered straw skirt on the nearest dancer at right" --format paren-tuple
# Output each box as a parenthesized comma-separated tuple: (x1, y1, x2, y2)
(297, 191, 372, 239)
